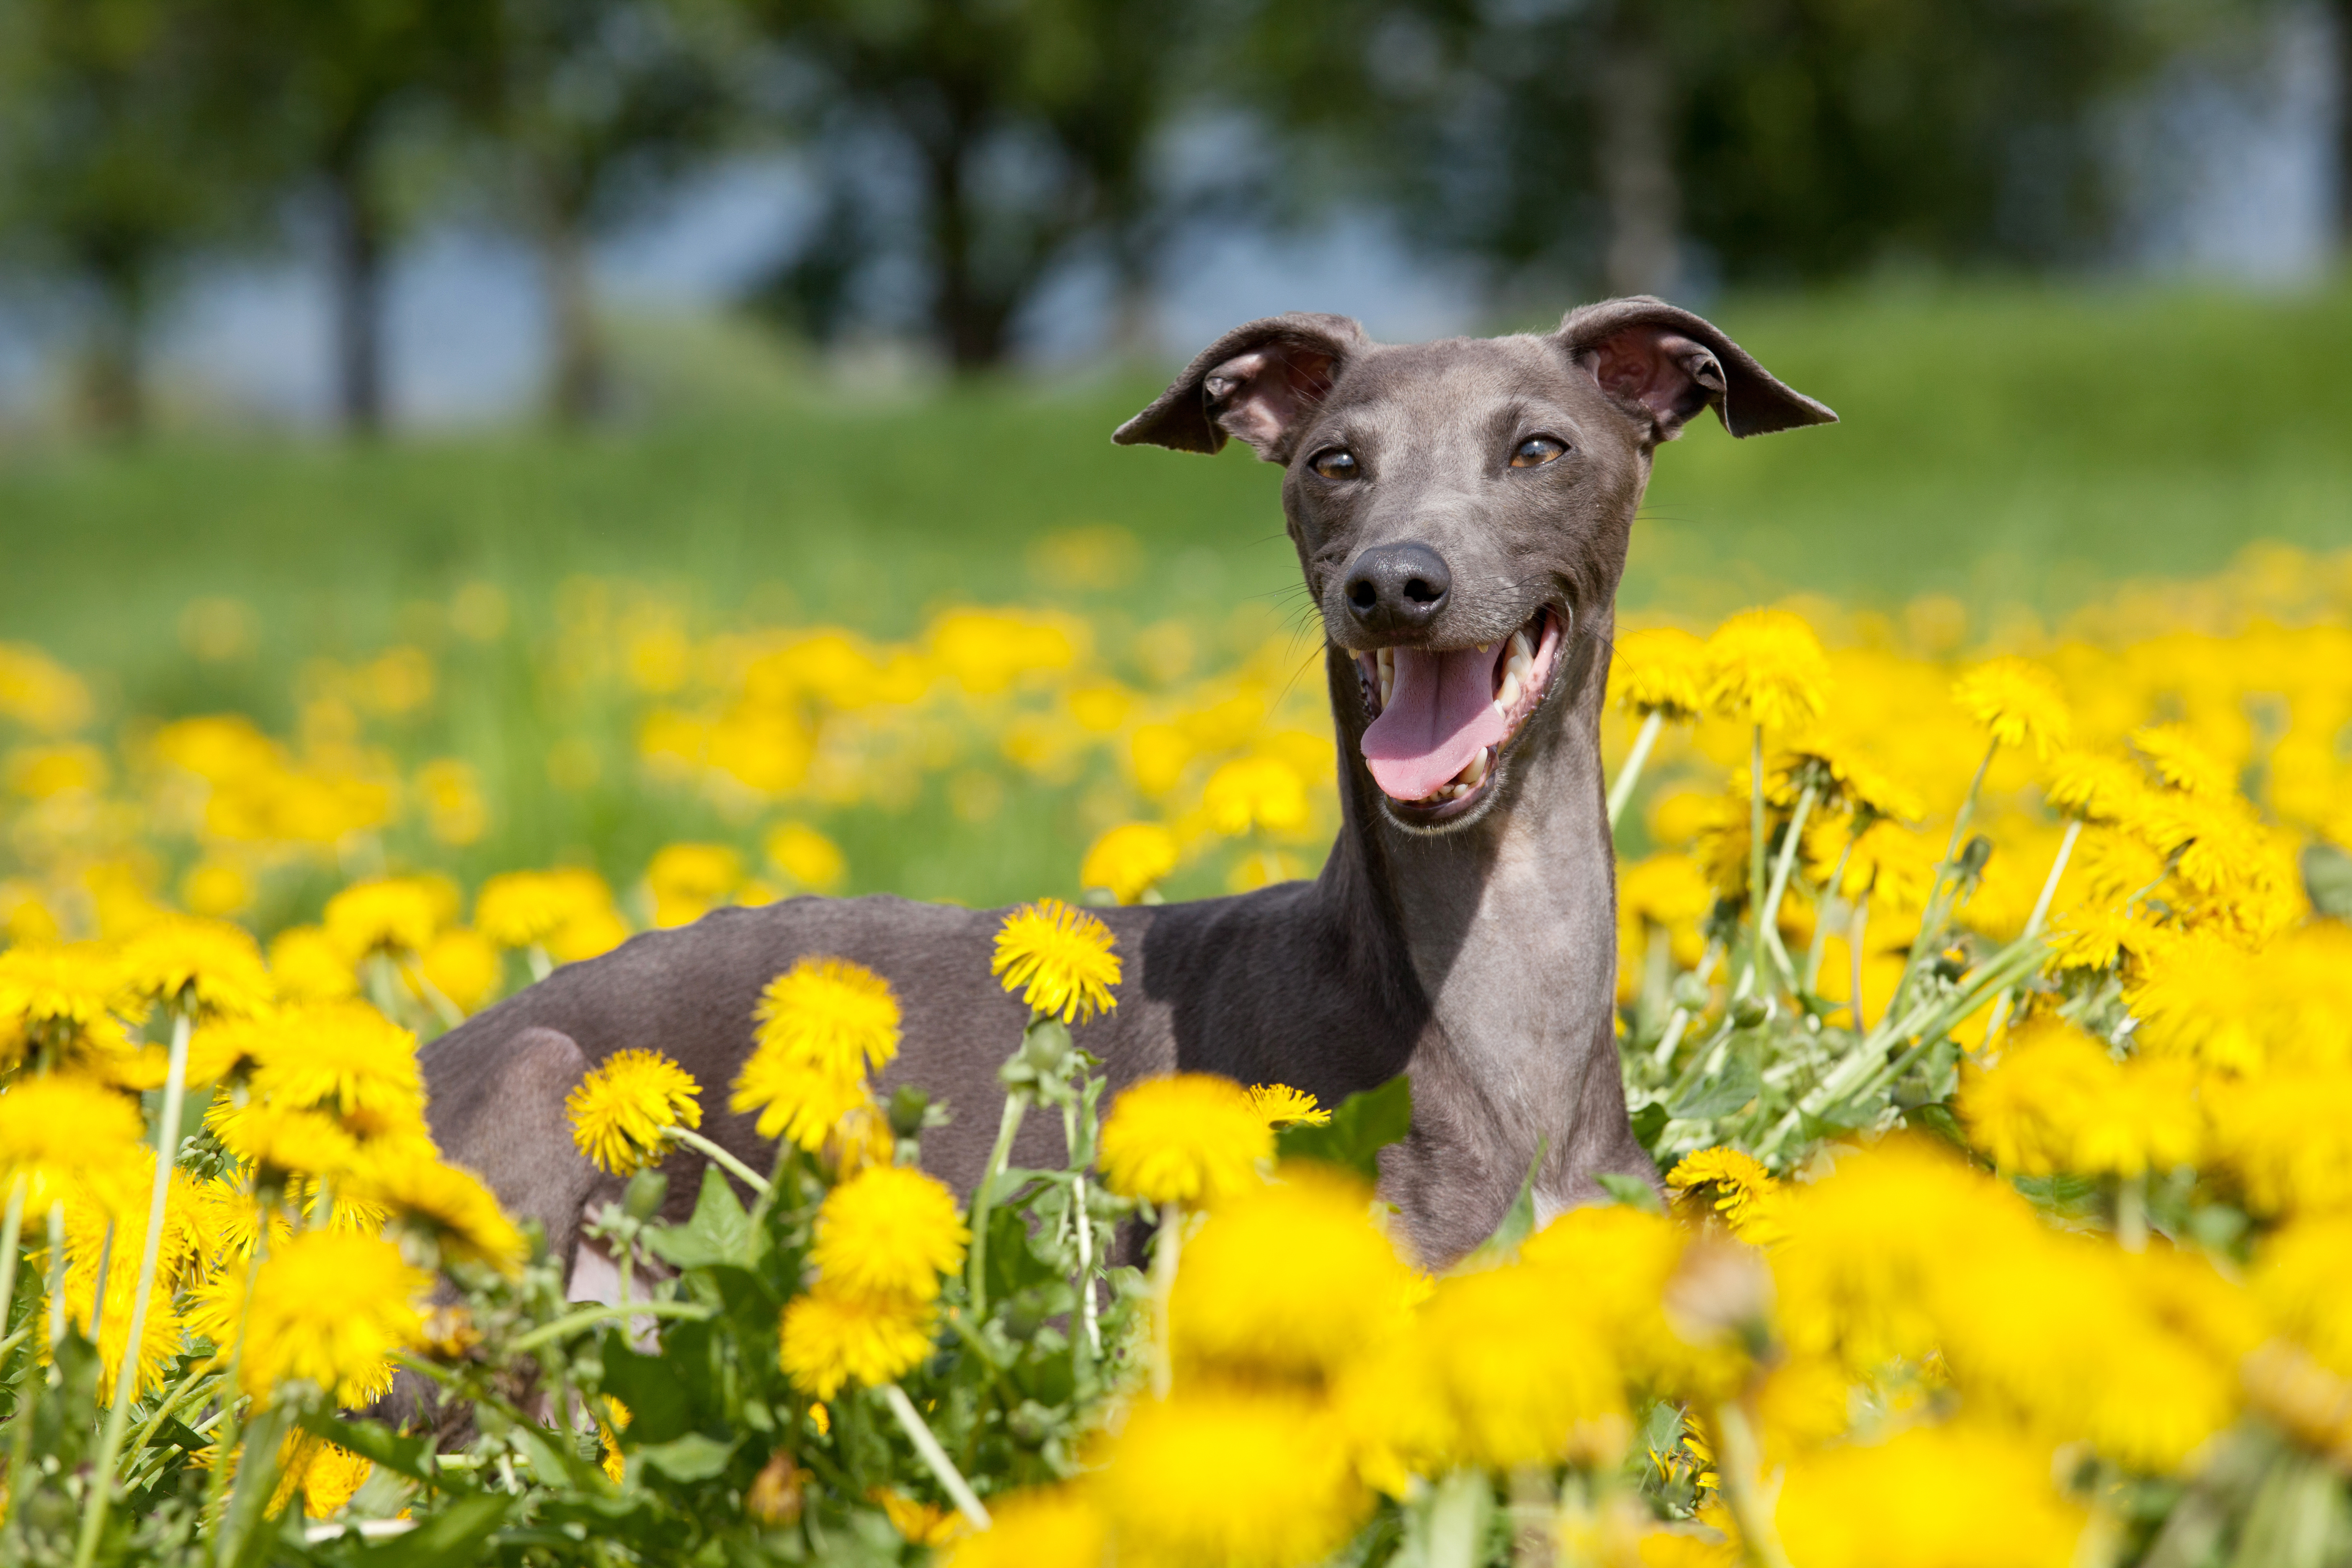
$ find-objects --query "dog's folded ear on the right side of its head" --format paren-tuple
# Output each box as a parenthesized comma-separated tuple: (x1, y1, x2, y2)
(1555, 294, 1837, 442)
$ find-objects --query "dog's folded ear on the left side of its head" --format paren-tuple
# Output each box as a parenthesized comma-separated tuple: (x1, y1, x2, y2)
(1110, 310, 1371, 463)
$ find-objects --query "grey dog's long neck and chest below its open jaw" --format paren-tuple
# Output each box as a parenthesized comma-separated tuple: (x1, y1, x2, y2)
(1320, 611, 1627, 1262)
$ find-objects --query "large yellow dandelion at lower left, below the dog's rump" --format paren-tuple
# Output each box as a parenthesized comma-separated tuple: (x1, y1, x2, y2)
(224, 1230, 433, 1403)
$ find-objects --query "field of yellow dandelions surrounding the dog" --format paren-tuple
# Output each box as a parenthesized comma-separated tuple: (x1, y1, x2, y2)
(0, 529, 2352, 1568)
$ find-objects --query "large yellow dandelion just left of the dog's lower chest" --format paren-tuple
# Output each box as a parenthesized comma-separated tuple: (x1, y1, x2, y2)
(1101, 1072, 1275, 1208)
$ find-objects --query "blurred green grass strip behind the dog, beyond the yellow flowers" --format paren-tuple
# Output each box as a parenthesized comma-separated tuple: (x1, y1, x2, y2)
(0, 287, 2352, 898)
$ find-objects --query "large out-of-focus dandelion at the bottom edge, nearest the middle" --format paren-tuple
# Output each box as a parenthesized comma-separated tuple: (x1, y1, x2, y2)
(1091, 1389, 1371, 1568)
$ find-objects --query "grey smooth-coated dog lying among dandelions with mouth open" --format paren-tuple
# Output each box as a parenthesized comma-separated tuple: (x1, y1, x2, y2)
(423, 299, 1837, 1293)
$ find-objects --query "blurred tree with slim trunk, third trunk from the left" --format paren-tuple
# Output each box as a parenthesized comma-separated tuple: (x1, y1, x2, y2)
(489, 0, 729, 423)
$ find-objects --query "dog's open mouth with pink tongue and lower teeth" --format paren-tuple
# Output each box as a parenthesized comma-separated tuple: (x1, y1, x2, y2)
(1355, 609, 1559, 816)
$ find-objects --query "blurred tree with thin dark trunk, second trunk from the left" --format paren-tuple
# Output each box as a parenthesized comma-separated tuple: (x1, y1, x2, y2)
(230, 0, 499, 435)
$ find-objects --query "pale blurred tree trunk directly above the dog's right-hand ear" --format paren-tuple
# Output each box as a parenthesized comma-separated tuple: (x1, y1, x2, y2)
(1597, 0, 1681, 294)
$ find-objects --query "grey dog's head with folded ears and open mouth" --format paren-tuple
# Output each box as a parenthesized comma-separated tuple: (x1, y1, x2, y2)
(1112, 299, 1837, 830)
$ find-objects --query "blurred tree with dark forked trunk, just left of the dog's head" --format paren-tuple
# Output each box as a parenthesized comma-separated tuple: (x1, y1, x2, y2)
(736, 0, 1188, 369)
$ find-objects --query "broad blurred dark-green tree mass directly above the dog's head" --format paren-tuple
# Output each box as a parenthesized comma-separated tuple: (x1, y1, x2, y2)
(1235, 0, 2182, 296)
